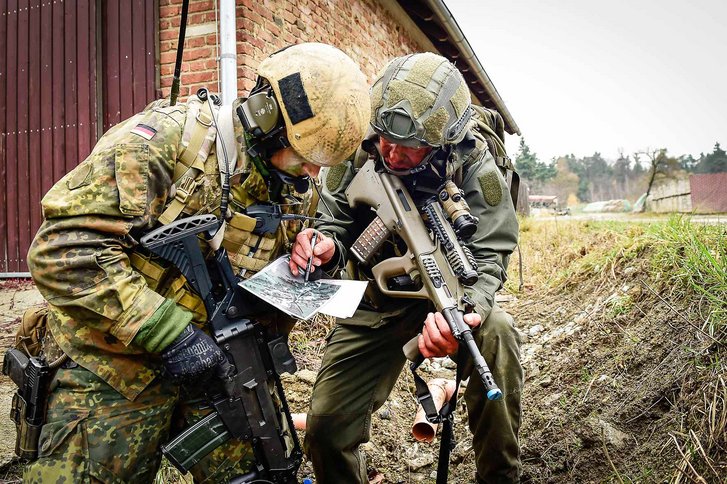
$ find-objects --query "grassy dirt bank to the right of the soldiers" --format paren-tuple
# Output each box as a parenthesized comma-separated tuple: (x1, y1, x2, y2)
(508, 218, 727, 483)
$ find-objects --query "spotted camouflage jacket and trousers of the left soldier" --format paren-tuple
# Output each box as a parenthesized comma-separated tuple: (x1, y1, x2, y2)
(26, 94, 313, 482)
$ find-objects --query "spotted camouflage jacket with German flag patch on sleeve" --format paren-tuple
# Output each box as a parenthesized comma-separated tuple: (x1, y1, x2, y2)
(28, 96, 312, 399)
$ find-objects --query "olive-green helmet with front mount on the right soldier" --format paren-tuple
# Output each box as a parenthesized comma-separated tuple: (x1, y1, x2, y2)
(371, 52, 472, 147)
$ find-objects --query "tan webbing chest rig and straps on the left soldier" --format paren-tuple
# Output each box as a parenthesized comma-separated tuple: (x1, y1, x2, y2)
(129, 93, 315, 323)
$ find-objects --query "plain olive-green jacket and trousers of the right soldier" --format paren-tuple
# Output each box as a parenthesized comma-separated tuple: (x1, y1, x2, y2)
(304, 140, 523, 484)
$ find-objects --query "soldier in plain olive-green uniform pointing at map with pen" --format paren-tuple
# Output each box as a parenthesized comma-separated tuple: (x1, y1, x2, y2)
(291, 53, 523, 484)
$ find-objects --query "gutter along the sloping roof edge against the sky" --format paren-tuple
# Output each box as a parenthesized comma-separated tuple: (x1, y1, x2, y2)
(425, 0, 520, 135)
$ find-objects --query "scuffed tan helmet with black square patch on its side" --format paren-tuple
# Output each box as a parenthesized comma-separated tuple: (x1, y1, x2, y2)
(257, 43, 371, 166)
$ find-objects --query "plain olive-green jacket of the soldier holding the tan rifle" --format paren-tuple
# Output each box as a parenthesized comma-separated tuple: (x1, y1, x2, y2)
(316, 134, 518, 327)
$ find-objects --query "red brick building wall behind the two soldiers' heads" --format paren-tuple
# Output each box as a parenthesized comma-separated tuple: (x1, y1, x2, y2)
(159, 0, 421, 98)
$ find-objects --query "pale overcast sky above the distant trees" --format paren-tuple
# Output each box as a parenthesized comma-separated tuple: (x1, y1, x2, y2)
(445, 0, 727, 161)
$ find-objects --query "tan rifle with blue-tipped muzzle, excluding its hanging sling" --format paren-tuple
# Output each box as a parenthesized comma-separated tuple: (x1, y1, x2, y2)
(346, 160, 502, 400)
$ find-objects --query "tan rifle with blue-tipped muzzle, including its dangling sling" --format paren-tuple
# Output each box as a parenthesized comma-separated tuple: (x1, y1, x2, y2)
(346, 160, 502, 484)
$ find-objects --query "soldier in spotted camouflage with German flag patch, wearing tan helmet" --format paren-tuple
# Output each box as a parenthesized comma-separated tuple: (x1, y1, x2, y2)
(24, 44, 370, 483)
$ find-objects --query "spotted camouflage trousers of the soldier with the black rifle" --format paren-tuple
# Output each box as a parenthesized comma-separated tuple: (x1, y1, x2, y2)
(23, 366, 253, 484)
